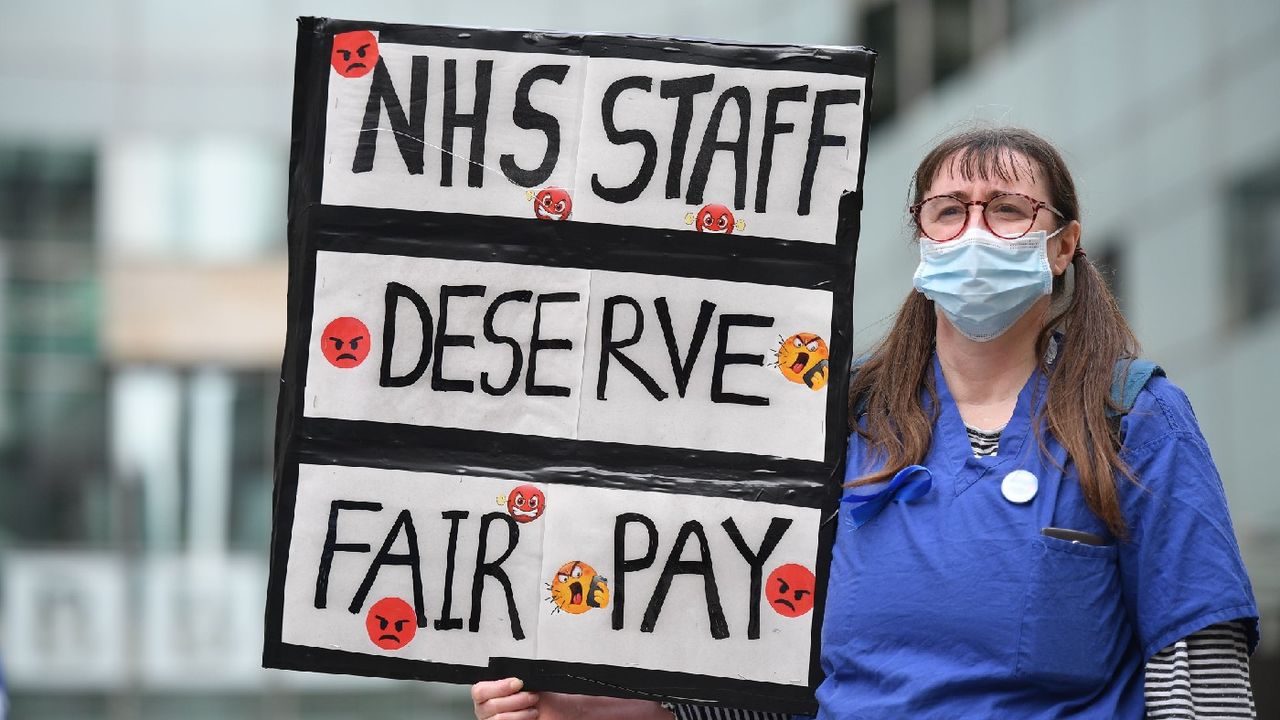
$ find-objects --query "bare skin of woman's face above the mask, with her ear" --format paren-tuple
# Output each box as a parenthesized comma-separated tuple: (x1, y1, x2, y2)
(920, 152, 1080, 275)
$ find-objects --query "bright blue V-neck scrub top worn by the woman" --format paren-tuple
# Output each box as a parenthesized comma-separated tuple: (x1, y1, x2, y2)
(818, 357, 1258, 720)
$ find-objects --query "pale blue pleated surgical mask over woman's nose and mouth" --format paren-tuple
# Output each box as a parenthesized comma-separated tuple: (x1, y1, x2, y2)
(914, 227, 1062, 342)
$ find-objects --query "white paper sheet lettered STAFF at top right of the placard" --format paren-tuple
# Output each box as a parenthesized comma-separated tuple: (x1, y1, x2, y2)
(575, 58, 865, 243)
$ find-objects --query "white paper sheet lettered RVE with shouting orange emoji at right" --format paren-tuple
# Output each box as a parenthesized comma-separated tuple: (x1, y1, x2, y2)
(577, 266, 831, 460)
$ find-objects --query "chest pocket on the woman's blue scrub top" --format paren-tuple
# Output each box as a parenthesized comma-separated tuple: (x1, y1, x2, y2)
(1016, 534, 1133, 687)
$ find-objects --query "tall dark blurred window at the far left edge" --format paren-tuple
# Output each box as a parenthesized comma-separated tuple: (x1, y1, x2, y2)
(0, 145, 109, 542)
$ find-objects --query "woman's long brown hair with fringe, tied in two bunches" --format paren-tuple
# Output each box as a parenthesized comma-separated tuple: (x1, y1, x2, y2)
(849, 128, 1138, 538)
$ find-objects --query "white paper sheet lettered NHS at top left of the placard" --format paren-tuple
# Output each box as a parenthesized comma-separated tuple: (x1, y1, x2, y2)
(323, 44, 586, 218)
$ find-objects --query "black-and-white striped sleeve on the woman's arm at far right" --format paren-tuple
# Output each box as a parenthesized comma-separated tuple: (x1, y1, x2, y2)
(1146, 621, 1257, 720)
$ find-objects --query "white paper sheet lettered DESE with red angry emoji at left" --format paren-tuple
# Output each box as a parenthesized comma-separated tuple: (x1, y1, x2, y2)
(306, 252, 590, 438)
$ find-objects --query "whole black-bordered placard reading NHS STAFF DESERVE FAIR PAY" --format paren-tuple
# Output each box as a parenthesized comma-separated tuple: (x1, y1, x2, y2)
(264, 18, 873, 711)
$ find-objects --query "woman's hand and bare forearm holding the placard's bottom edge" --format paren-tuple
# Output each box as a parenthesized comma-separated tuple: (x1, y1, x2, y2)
(471, 678, 671, 720)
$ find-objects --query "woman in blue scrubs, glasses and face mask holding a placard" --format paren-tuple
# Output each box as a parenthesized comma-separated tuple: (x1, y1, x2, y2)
(472, 129, 1257, 720)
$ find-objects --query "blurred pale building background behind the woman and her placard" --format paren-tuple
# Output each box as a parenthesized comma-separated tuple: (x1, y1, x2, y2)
(0, 0, 1280, 720)
